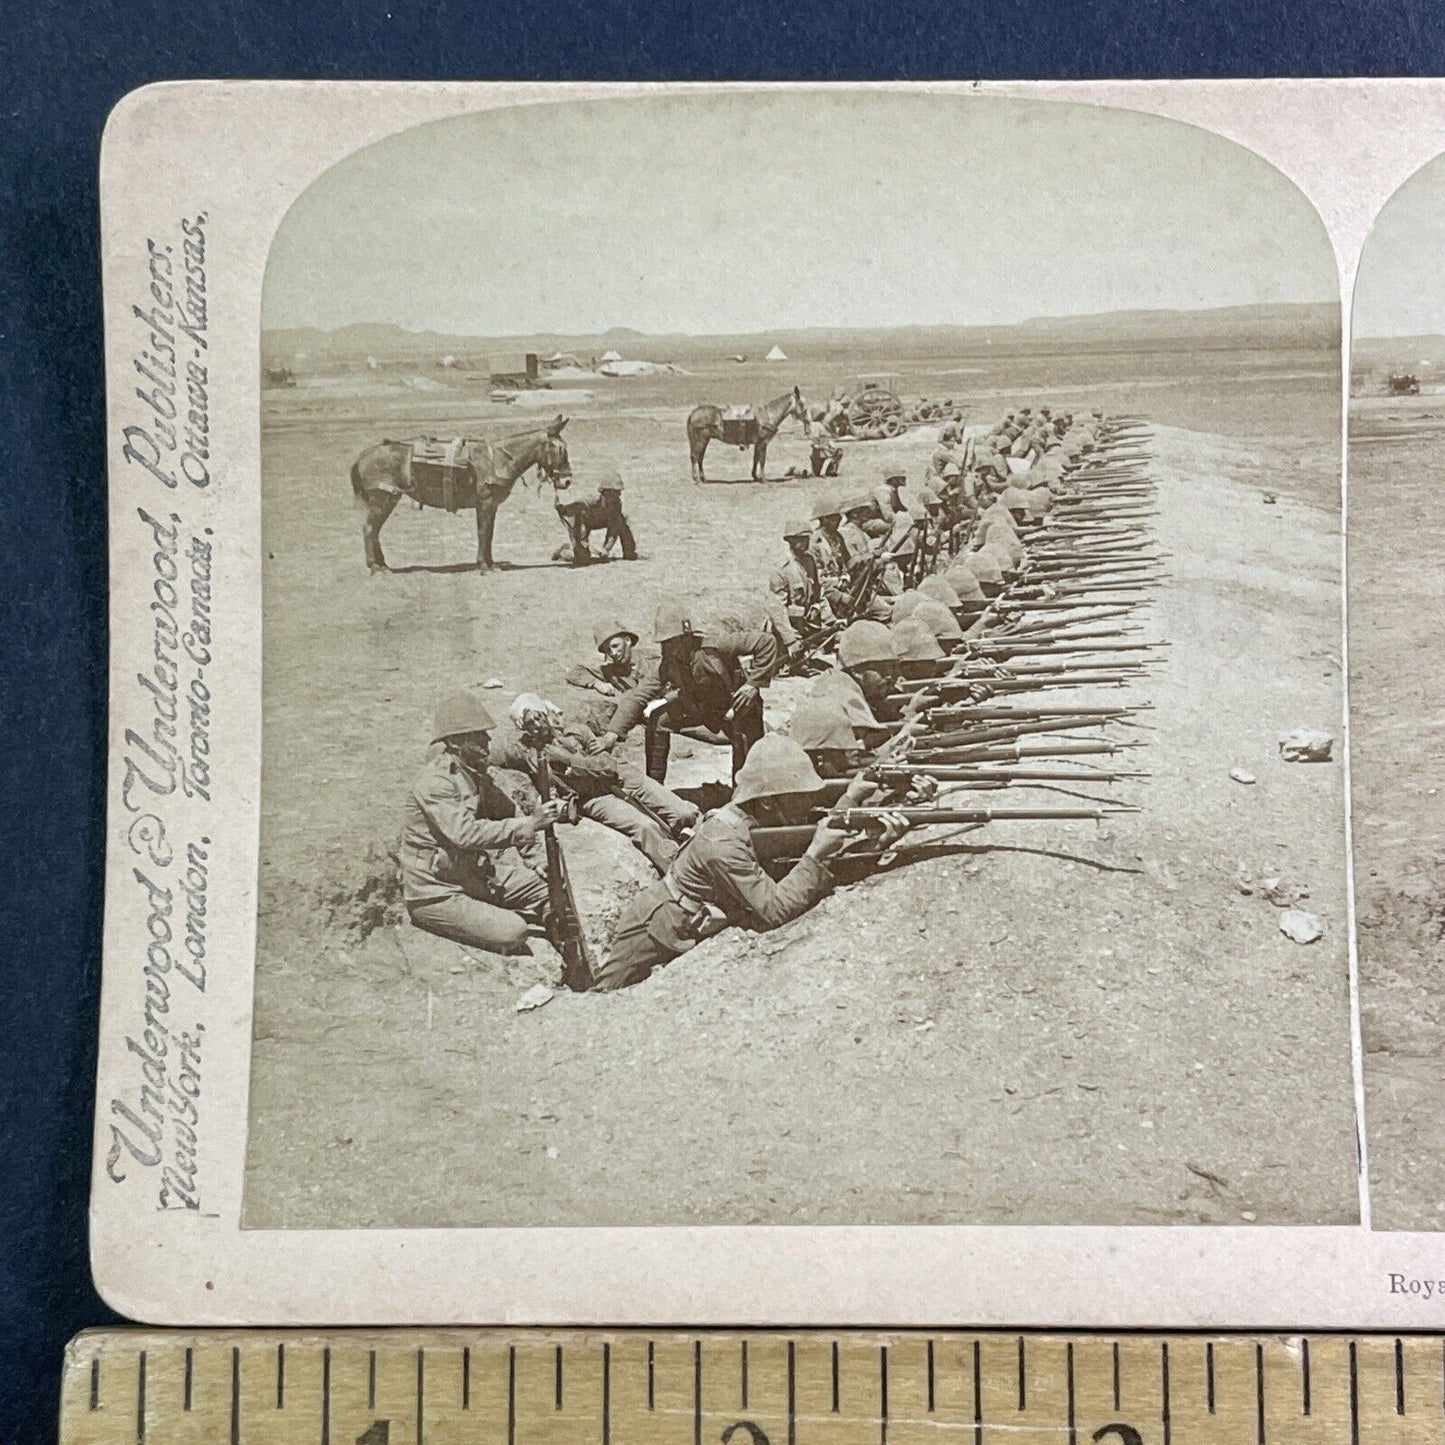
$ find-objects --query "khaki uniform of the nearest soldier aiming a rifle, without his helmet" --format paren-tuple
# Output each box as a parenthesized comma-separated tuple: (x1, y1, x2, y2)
(592, 805, 832, 991)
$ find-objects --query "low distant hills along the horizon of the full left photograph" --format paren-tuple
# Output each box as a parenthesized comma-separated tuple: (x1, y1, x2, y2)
(262, 302, 1340, 360)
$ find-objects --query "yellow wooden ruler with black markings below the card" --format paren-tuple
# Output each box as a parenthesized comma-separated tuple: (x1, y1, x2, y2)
(61, 1329, 1445, 1445)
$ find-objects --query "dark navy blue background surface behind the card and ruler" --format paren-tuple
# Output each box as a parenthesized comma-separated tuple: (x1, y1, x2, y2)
(0, 0, 1445, 1442)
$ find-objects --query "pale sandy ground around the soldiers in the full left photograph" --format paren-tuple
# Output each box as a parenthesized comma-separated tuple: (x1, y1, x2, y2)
(244, 375, 1357, 1227)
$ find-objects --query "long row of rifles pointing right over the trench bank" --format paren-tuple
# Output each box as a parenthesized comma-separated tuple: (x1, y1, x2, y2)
(753, 418, 1168, 861)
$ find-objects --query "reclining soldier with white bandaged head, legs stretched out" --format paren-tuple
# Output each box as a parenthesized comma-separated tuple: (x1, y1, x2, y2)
(491, 692, 698, 873)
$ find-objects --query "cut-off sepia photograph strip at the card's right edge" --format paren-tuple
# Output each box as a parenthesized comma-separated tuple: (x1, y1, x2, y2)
(1348, 152, 1445, 1230)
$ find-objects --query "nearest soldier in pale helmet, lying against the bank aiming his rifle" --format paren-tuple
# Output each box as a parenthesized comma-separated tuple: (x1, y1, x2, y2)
(592, 734, 872, 991)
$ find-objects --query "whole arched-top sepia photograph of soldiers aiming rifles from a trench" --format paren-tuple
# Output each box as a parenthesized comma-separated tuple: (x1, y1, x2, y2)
(231, 90, 1360, 1230)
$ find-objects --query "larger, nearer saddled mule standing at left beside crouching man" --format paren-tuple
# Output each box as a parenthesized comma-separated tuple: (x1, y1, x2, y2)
(351, 416, 572, 572)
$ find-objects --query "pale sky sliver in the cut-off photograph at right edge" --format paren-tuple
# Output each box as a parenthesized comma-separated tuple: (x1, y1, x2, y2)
(1353, 156, 1445, 337)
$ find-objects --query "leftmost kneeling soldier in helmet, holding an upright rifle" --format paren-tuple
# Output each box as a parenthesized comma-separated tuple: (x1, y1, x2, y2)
(400, 692, 565, 954)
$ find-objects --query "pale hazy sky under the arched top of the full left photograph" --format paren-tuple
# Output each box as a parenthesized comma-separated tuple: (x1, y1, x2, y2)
(263, 92, 1338, 335)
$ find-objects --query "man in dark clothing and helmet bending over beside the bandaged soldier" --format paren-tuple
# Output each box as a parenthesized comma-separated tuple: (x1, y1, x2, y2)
(604, 603, 782, 783)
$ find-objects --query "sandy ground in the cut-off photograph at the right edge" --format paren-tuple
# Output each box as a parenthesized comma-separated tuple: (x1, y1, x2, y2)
(1350, 396, 1445, 1230)
